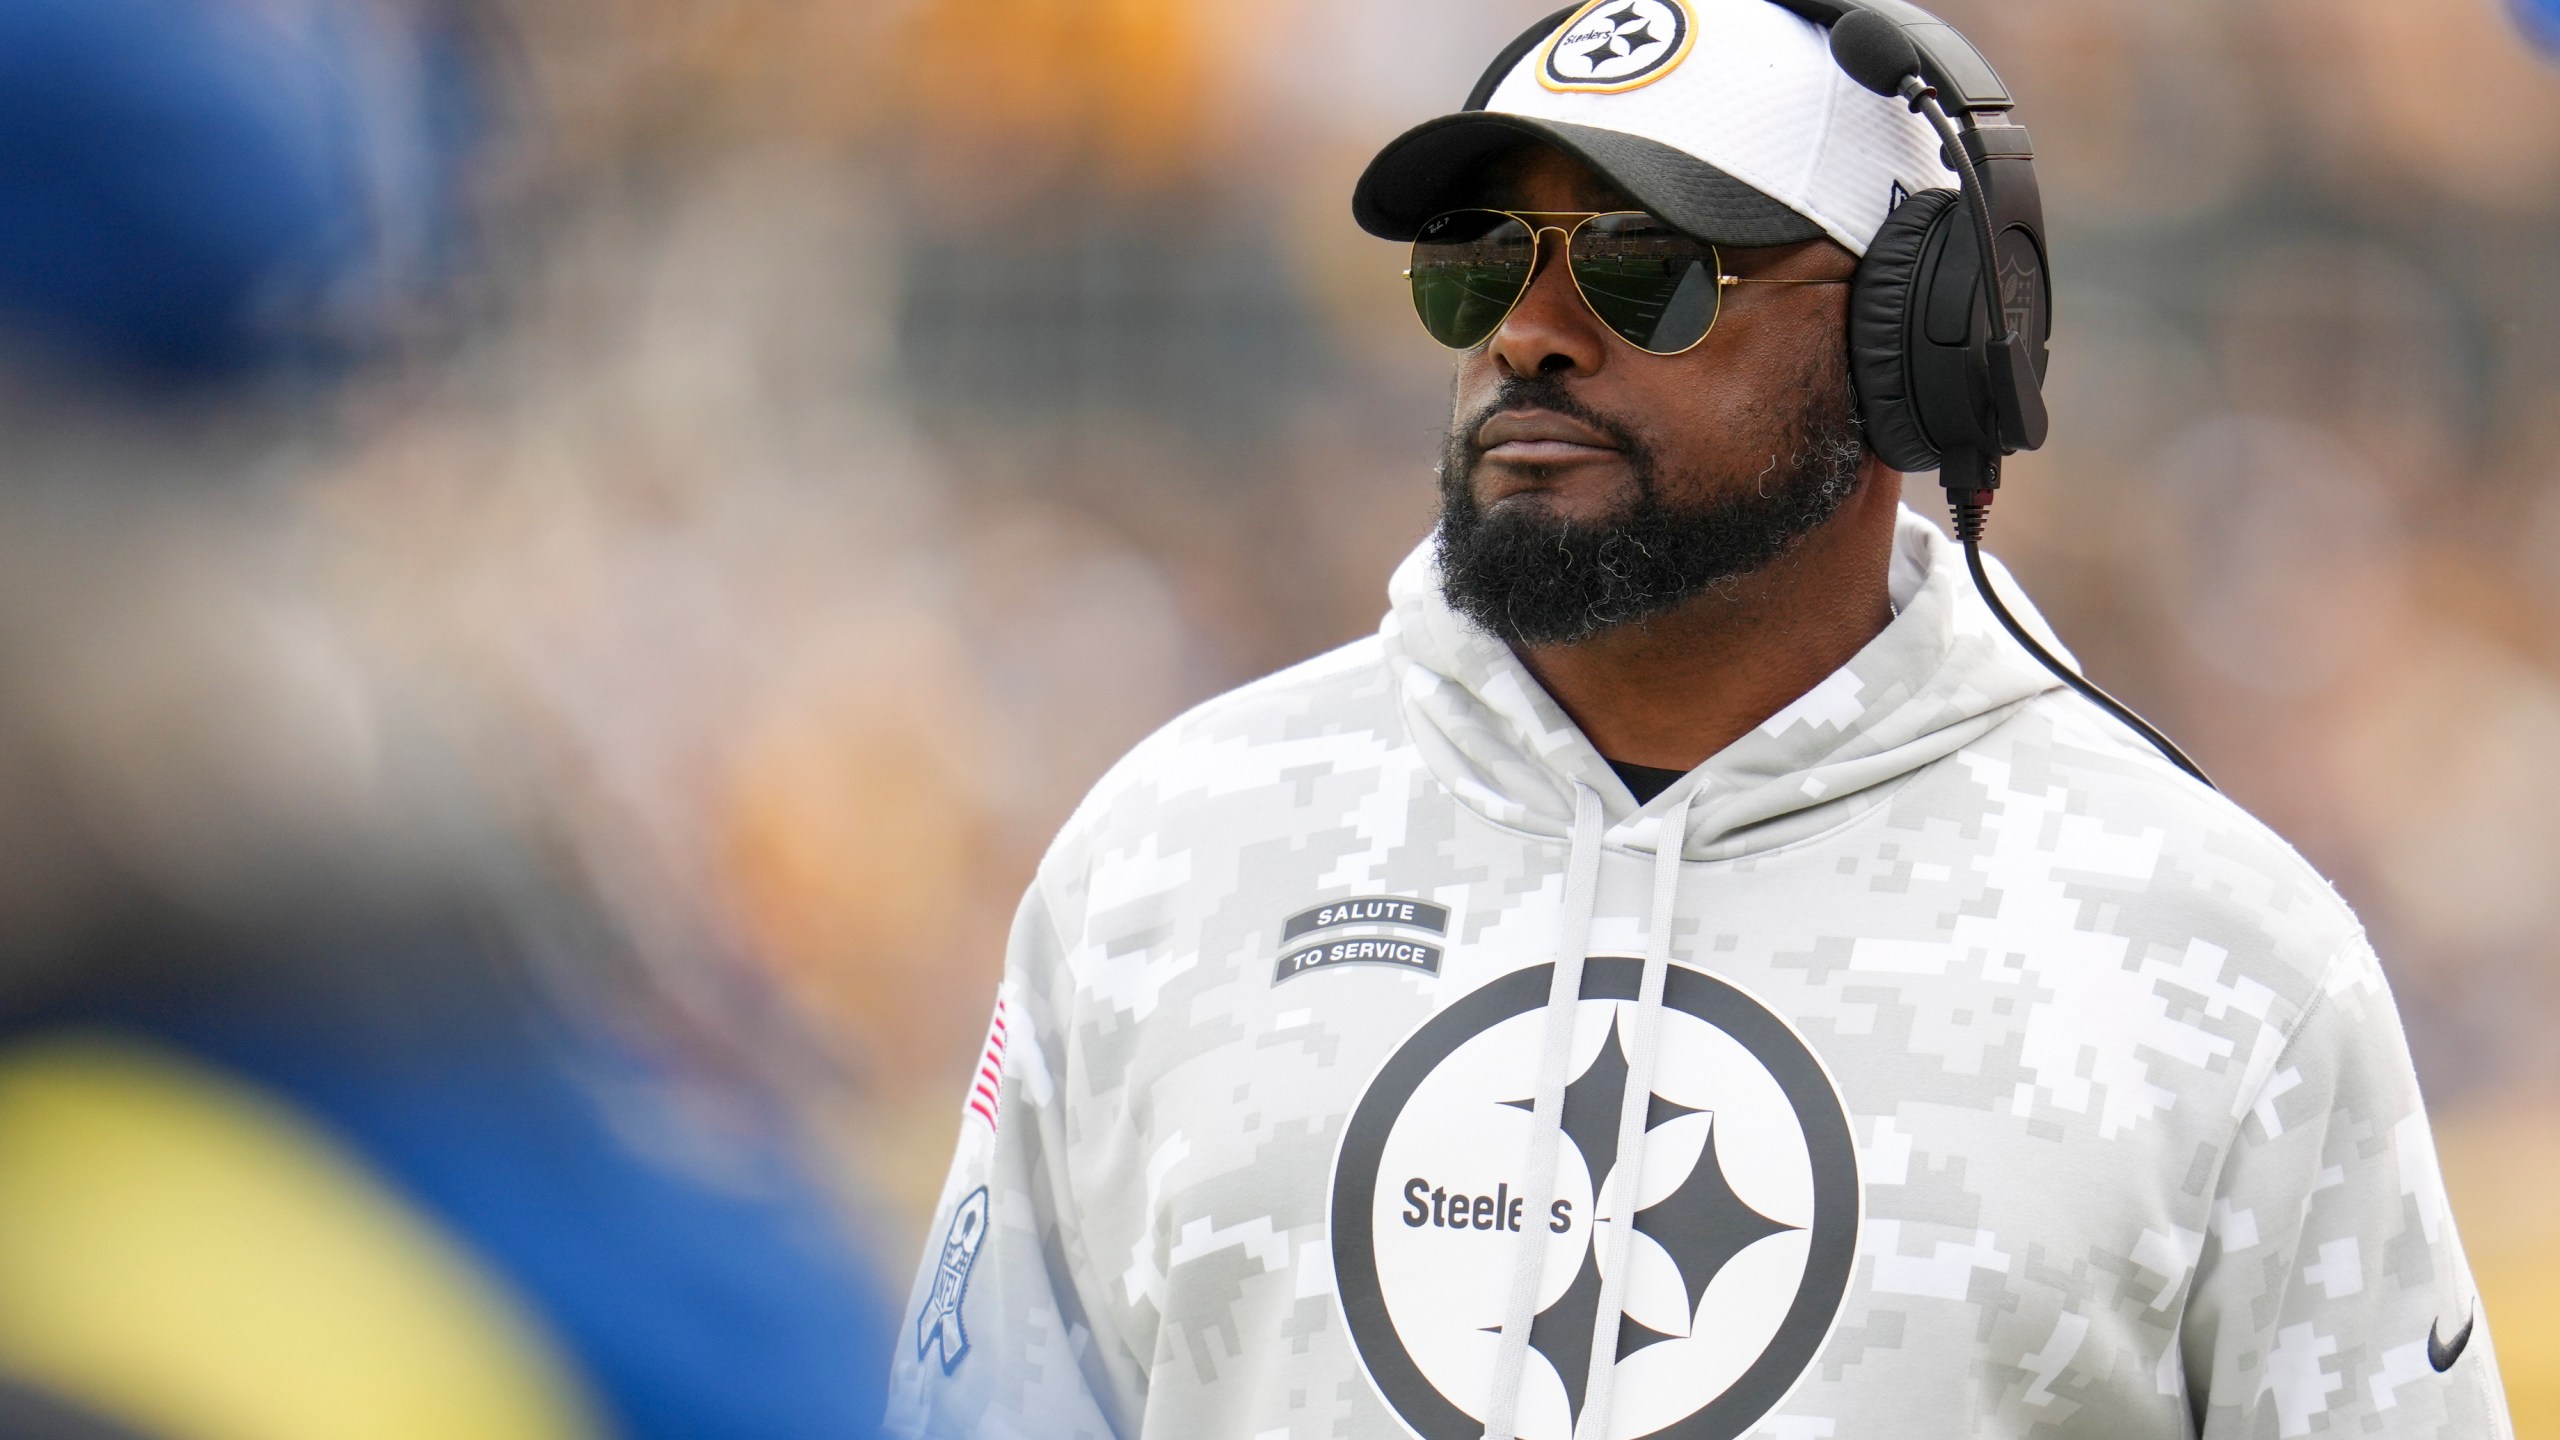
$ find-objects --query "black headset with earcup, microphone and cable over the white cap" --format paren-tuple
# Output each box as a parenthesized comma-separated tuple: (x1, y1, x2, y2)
(1464, 0, 2212, 787)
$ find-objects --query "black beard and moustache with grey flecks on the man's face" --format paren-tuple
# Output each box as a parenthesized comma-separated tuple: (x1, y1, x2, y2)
(1439, 359, 1866, 646)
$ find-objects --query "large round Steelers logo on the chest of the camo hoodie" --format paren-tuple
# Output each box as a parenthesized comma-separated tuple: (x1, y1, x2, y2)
(1331, 956, 1859, 1440)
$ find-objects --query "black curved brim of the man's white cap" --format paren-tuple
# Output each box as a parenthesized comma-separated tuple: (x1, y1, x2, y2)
(1352, 110, 1823, 246)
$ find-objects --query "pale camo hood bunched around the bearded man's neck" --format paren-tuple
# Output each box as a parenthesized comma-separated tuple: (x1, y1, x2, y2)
(1380, 507, 2066, 861)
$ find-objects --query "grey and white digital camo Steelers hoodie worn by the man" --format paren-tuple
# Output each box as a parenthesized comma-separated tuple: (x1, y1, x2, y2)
(891, 515, 2509, 1440)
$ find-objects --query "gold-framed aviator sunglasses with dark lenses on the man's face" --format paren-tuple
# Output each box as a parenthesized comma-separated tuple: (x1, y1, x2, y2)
(1405, 210, 1848, 356)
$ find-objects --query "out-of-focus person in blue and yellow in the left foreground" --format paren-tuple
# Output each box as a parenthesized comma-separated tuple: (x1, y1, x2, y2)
(0, 0, 886, 1440)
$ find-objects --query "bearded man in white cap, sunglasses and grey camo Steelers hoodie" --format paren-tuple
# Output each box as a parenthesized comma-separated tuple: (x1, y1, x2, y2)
(891, 0, 2506, 1440)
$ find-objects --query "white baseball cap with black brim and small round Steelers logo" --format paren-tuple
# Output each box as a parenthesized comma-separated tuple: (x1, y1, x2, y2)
(1352, 0, 1956, 256)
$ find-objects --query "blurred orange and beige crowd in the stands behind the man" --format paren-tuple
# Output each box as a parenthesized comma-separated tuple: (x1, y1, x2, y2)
(0, 0, 2560, 1437)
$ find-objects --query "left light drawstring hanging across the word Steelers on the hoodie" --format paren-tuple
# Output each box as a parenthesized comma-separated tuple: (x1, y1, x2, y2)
(1485, 784, 1600, 1440)
